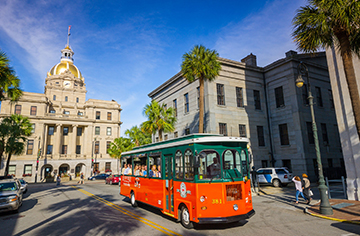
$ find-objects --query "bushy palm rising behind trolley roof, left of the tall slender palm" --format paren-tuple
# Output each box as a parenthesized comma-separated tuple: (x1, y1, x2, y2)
(141, 100, 176, 141)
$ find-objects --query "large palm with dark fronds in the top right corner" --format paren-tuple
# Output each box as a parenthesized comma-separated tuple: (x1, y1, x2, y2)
(292, 0, 360, 137)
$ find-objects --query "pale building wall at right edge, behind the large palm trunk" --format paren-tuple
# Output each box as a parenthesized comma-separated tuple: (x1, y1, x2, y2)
(326, 48, 360, 201)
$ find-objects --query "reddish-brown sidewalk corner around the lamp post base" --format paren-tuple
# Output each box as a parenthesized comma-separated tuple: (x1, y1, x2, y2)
(304, 199, 360, 225)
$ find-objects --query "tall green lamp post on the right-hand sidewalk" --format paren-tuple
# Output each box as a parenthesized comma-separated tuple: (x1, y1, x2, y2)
(295, 62, 333, 215)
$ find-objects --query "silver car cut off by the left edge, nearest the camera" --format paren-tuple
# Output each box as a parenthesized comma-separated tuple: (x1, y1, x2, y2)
(0, 179, 23, 212)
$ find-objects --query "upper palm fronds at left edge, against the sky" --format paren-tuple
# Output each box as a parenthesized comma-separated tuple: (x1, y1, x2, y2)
(0, 50, 22, 101)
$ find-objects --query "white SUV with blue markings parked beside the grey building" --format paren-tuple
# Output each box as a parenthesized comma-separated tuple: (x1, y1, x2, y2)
(256, 167, 292, 187)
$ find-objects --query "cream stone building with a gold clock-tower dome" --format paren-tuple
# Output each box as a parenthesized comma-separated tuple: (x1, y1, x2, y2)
(0, 45, 121, 182)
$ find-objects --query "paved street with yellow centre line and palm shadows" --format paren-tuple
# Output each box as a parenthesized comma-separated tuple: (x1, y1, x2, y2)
(0, 181, 360, 236)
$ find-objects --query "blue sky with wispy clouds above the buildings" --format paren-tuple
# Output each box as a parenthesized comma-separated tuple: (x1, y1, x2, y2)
(0, 0, 306, 134)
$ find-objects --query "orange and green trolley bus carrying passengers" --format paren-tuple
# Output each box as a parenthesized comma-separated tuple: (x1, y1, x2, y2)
(120, 134, 255, 228)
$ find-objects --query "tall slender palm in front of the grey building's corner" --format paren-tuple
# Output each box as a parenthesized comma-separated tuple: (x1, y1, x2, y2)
(181, 45, 221, 133)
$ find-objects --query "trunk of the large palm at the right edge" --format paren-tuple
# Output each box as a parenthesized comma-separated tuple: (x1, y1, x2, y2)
(336, 33, 360, 138)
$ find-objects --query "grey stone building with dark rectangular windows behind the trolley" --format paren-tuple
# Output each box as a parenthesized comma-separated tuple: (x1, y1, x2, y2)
(149, 51, 343, 180)
